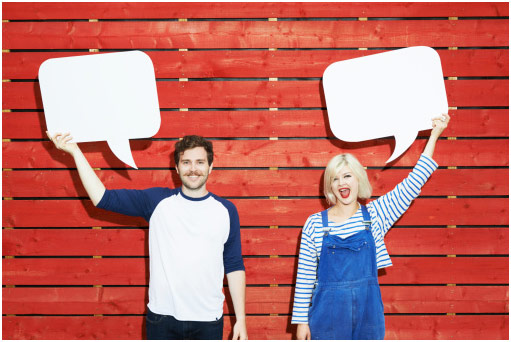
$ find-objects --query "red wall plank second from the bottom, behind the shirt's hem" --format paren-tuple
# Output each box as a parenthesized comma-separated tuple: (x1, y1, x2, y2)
(2, 286, 509, 315)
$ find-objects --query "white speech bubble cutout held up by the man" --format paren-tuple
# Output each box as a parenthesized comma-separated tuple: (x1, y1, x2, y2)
(39, 51, 161, 169)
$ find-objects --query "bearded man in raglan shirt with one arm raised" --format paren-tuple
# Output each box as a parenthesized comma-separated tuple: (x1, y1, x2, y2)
(47, 132, 247, 340)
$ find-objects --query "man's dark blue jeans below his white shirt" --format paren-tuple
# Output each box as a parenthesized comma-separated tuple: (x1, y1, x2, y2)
(146, 309, 224, 340)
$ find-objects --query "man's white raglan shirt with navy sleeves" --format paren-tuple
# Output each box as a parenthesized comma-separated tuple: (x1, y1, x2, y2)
(98, 188, 245, 321)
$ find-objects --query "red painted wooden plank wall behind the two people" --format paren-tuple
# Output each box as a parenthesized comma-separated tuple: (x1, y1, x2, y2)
(2, 3, 509, 339)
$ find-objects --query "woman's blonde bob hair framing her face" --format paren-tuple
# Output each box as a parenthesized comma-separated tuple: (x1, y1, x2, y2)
(323, 153, 373, 205)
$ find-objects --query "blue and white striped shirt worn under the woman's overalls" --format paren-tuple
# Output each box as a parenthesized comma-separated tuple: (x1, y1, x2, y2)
(291, 155, 438, 324)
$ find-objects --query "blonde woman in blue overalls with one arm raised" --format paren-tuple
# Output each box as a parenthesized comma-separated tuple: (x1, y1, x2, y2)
(292, 114, 450, 340)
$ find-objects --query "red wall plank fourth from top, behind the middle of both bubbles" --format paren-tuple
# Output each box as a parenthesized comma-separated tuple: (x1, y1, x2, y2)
(2, 79, 509, 109)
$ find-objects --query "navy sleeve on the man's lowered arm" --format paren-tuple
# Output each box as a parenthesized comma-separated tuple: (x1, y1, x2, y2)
(221, 199, 245, 274)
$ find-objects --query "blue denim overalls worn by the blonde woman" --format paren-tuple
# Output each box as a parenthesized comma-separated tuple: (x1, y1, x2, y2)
(309, 206, 385, 340)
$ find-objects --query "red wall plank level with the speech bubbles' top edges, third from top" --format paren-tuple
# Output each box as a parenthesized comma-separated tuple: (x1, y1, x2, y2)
(2, 49, 509, 79)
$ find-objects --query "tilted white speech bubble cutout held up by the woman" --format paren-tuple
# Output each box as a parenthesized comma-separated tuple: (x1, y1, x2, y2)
(323, 46, 448, 163)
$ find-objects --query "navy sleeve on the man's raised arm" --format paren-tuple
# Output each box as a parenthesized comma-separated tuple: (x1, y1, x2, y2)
(97, 188, 176, 222)
